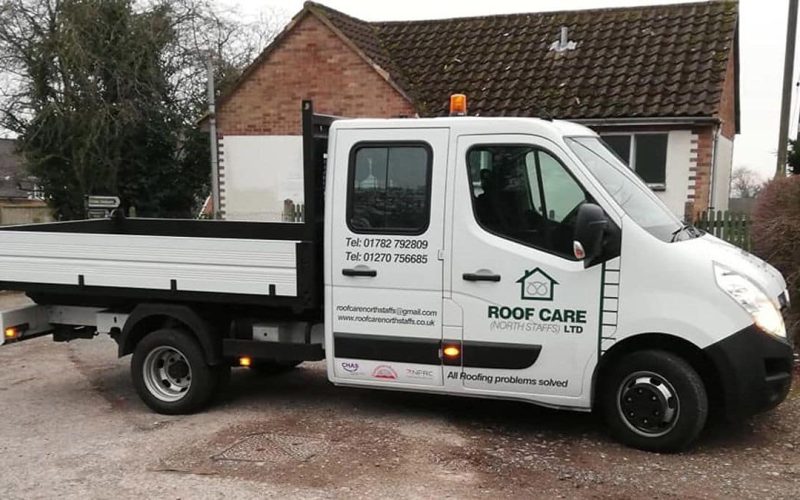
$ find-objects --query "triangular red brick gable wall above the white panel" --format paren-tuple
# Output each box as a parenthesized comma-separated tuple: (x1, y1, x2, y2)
(217, 15, 416, 136)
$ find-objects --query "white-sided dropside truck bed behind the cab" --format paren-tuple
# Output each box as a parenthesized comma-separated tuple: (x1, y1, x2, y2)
(0, 218, 322, 310)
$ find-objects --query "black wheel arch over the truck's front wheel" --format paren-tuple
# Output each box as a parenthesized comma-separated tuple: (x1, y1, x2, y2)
(592, 333, 724, 409)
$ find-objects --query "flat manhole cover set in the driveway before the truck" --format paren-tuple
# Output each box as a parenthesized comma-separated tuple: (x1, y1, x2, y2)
(213, 434, 328, 462)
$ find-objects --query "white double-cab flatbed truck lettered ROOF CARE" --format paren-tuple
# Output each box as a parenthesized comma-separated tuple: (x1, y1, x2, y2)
(0, 101, 793, 451)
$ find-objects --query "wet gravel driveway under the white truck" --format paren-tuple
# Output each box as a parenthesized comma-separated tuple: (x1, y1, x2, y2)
(0, 294, 800, 499)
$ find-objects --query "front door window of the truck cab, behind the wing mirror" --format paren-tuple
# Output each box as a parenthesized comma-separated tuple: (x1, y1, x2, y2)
(467, 145, 590, 259)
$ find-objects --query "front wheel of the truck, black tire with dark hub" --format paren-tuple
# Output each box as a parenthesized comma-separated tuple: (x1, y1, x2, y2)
(598, 350, 708, 452)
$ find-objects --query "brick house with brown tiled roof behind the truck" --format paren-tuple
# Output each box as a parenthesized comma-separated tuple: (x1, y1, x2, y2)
(211, 0, 739, 220)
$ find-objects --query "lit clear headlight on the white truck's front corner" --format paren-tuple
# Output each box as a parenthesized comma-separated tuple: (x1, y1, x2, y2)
(714, 263, 786, 338)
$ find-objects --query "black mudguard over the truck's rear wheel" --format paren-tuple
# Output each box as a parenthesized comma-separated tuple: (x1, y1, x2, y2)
(118, 304, 222, 365)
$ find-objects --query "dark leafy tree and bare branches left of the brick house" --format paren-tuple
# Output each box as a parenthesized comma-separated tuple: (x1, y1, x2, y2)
(0, 0, 286, 218)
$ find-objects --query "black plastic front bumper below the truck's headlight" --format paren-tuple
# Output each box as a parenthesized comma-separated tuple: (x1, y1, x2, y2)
(704, 325, 793, 420)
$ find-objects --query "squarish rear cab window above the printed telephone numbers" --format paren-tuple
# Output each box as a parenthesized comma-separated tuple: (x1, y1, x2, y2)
(347, 143, 432, 234)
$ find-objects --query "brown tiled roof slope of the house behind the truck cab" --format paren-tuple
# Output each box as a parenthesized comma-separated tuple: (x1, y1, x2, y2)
(306, 0, 738, 119)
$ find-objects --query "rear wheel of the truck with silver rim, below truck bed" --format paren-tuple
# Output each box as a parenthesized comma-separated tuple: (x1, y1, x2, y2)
(131, 329, 217, 415)
